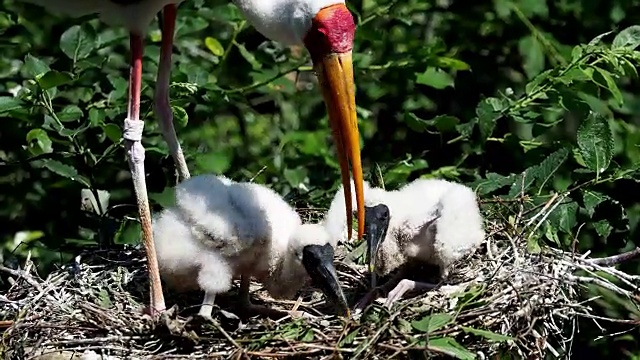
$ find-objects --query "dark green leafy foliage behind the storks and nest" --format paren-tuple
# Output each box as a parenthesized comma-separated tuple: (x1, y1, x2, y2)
(0, 0, 640, 358)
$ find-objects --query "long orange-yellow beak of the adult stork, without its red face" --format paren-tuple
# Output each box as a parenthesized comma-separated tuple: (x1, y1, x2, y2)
(315, 51, 364, 239)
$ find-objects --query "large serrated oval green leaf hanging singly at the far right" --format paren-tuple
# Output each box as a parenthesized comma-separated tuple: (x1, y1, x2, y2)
(577, 112, 614, 175)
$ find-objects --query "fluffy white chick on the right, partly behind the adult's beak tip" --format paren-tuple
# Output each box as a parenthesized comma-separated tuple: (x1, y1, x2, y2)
(325, 179, 485, 309)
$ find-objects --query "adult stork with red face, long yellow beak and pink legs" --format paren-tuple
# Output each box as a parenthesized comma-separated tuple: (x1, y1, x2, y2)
(22, 0, 364, 314)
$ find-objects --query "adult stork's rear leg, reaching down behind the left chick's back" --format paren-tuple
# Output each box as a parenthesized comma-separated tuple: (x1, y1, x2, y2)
(154, 4, 191, 181)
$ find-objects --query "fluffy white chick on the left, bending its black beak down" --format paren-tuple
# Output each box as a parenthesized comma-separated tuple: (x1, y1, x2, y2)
(153, 175, 347, 317)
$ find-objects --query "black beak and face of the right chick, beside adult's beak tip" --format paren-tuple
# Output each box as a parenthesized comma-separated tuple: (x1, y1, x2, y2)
(364, 204, 389, 287)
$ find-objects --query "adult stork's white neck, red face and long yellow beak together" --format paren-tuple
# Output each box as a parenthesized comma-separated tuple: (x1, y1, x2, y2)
(234, 0, 364, 242)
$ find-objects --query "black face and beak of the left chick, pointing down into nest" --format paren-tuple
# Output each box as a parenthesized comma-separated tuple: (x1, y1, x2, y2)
(302, 244, 351, 317)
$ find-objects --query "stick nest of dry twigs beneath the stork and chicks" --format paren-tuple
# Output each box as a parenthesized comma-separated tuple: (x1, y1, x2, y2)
(0, 196, 640, 359)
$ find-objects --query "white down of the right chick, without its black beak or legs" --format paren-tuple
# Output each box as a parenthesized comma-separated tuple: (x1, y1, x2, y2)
(324, 179, 485, 277)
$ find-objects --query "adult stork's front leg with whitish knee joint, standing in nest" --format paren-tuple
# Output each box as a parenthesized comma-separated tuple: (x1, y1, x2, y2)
(122, 33, 165, 316)
